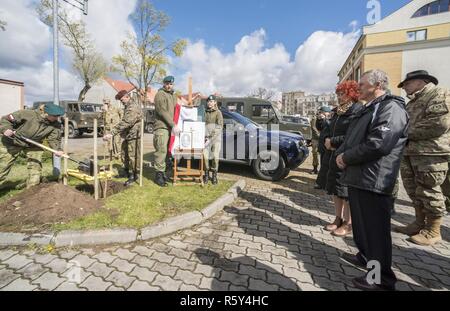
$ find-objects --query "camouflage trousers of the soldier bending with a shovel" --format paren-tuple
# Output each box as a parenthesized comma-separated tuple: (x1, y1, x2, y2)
(0, 142, 44, 188)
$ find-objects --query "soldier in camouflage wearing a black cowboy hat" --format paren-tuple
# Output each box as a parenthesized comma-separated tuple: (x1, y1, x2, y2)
(396, 70, 450, 246)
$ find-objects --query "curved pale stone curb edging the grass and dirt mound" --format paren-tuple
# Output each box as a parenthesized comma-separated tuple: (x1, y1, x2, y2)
(0, 179, 246, 247)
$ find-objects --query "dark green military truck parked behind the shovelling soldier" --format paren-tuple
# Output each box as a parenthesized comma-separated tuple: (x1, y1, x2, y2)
(33, 101, 104, 138)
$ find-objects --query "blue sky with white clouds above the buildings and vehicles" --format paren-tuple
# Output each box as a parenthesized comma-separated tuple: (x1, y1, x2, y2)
(0, 0, 409, 102)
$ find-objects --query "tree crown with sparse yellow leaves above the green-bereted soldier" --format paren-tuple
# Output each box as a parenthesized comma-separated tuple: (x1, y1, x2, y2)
(113, 0, 187, 103)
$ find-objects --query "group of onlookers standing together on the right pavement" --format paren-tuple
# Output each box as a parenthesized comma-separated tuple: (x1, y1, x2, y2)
(311, 70, 450, 290)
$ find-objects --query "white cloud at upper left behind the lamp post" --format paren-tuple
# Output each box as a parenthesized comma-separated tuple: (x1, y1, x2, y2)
(0, 0, 136, 104)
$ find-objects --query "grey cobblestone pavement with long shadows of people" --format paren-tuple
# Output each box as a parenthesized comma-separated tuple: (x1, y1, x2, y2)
(0, 158, 450, 291)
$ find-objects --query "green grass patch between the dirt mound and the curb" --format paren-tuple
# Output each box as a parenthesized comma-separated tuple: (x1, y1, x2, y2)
(54, 179, 233, 230)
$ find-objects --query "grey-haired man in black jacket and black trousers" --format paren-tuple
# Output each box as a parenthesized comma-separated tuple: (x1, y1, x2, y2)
(336, 70, 409, 290)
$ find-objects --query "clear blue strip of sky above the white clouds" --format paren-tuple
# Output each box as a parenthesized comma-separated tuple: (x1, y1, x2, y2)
(153, 0, 409, 53)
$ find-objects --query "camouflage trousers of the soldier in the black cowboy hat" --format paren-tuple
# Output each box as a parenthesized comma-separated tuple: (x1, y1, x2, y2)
(401, 156, 450, 217)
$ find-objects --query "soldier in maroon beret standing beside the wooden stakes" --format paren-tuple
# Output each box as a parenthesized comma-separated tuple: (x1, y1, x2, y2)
(103, 90, 143, 186)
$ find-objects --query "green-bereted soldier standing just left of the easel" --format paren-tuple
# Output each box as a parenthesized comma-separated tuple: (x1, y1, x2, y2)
(153, 76, 180, 187)
